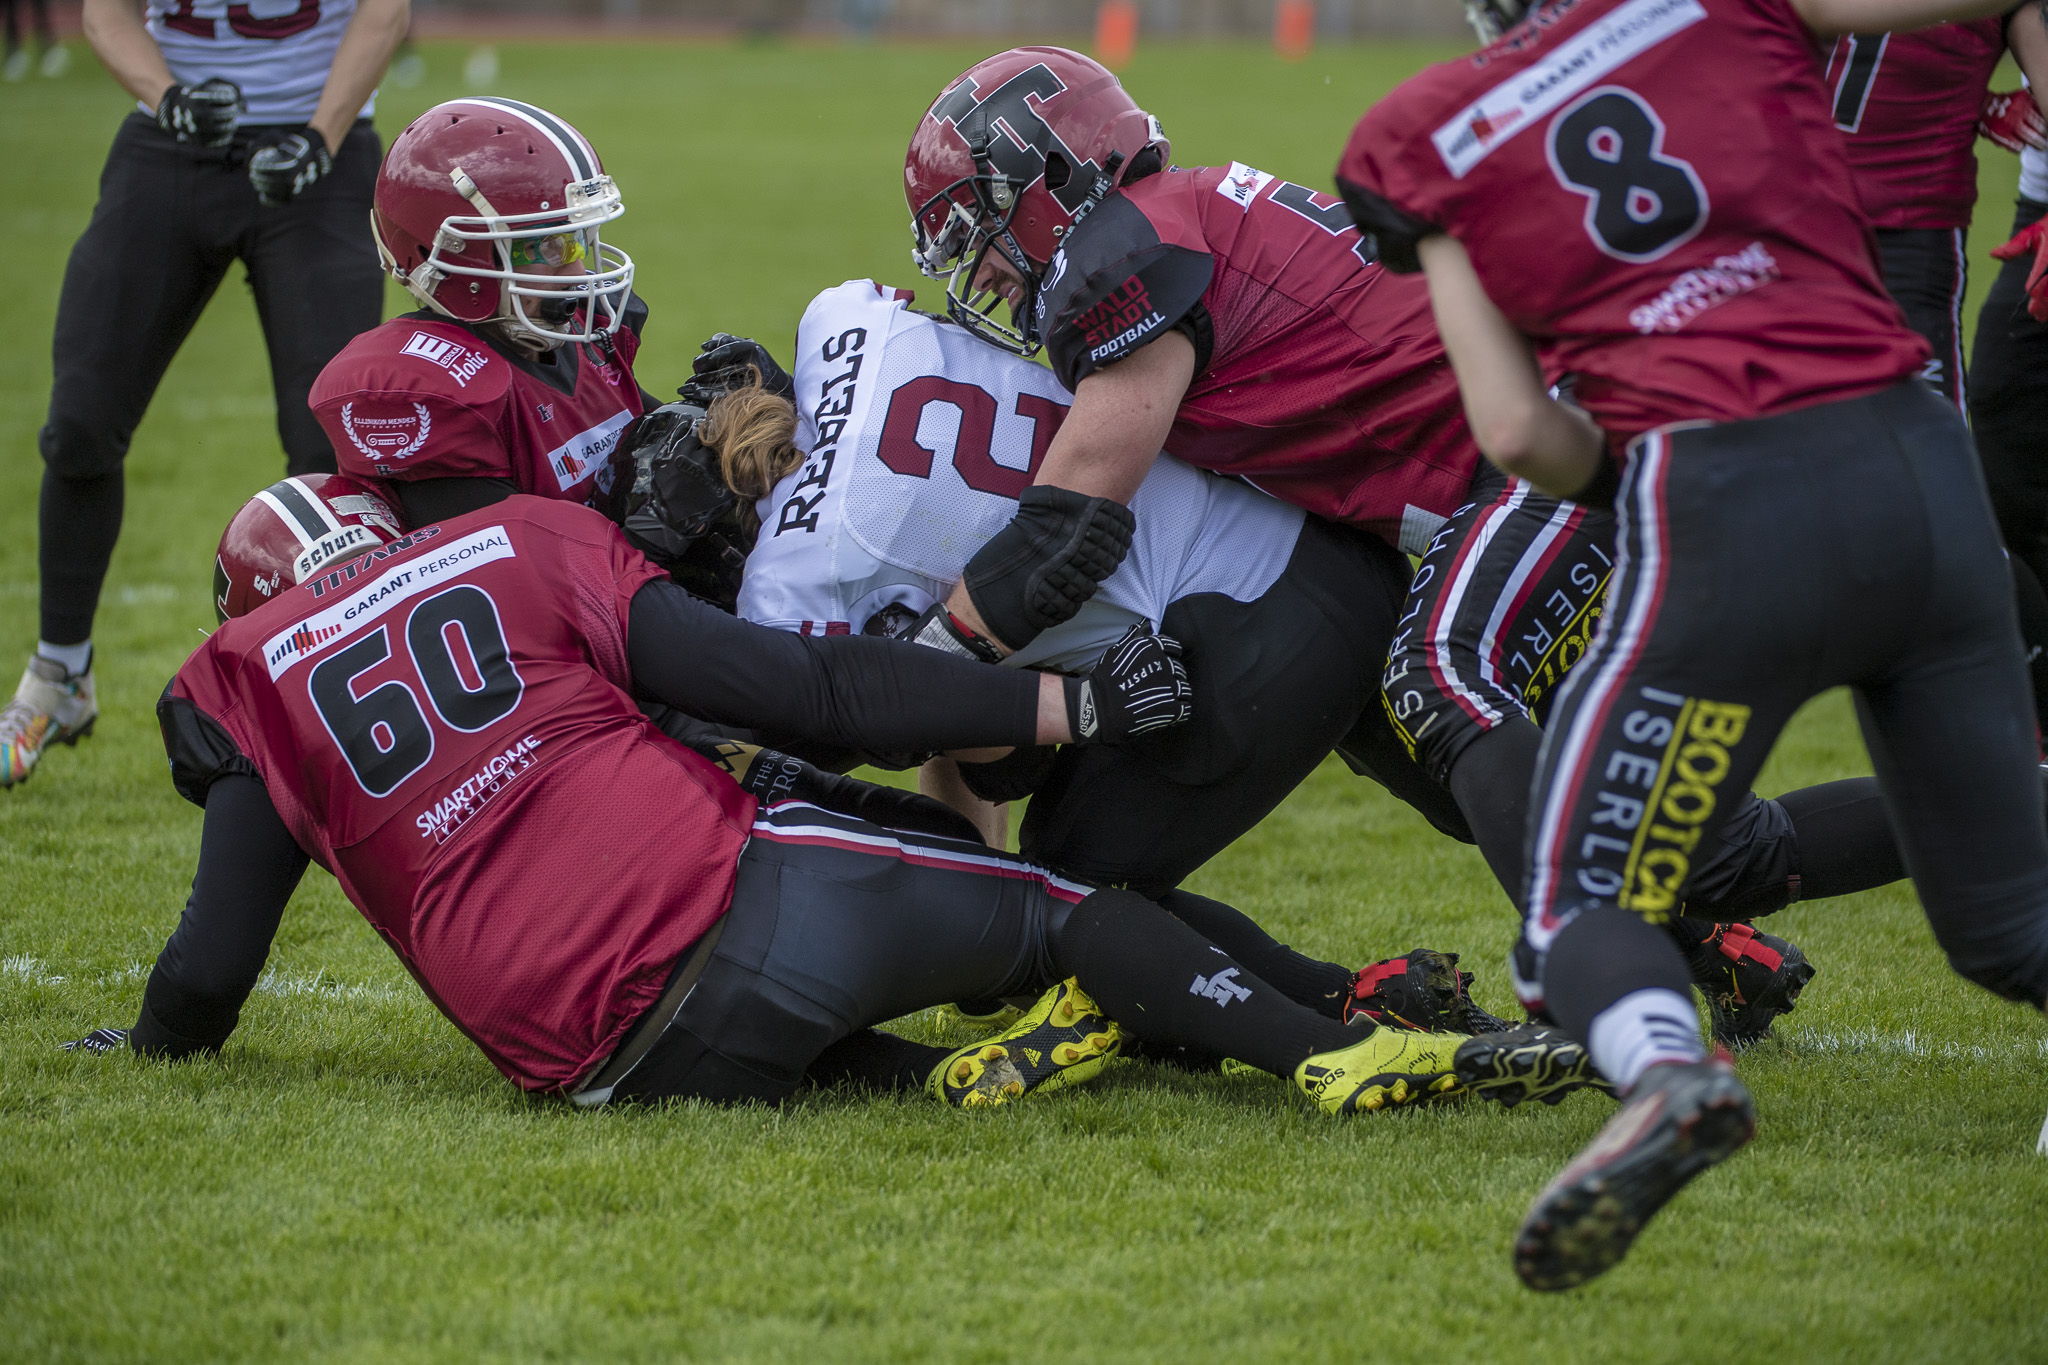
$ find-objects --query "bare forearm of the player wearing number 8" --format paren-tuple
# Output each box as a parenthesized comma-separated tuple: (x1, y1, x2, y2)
(1419, 235, 1604, 497)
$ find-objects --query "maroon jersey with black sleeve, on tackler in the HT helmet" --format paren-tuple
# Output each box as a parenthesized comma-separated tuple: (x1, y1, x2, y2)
(1040, 164, 1479, 551)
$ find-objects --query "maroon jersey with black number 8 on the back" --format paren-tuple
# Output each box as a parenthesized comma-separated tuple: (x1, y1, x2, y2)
(1337, 0, 1927, 438)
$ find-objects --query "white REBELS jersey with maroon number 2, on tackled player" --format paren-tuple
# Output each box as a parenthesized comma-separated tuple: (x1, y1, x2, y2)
(739, 280, 1303, 671)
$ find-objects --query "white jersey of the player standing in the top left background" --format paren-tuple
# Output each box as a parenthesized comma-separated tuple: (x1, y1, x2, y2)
(139, 0, 377, 123)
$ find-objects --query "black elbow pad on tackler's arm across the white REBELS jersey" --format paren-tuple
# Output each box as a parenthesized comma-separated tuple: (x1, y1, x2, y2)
(961, 483, 1137, 649)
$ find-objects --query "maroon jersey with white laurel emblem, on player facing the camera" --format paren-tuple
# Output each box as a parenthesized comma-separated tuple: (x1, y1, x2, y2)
(307, 313, 641, 501)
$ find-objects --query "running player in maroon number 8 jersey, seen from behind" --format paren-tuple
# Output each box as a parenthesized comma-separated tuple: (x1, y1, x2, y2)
(1337, 0, 2048, 1289)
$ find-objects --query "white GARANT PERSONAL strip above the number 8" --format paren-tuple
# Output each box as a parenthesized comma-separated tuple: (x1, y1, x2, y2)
(1433, 0, 1706, 180)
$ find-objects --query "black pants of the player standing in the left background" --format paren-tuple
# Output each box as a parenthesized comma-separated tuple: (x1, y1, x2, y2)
(37, 113, 383, 645)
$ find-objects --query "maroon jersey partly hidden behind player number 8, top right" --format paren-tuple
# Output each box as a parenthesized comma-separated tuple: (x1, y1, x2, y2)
(1827, 18, 2005, 227)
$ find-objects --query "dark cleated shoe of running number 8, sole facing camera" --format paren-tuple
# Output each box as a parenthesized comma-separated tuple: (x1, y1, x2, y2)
(1516, 1056, 1757, 1289)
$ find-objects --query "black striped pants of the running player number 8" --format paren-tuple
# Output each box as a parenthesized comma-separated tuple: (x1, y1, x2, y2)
(1516, 381, 2048, 1040)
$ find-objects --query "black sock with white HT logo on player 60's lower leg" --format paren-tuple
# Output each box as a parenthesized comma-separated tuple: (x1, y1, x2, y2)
(1051, 890, 1360, 1076)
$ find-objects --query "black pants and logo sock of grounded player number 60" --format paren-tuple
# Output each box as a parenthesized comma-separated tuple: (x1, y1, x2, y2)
(612, 802, 1356, 1103)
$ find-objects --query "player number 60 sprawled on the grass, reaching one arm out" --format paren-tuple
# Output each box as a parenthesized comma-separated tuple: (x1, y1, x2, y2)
(64, 481, 1583, 1111)
